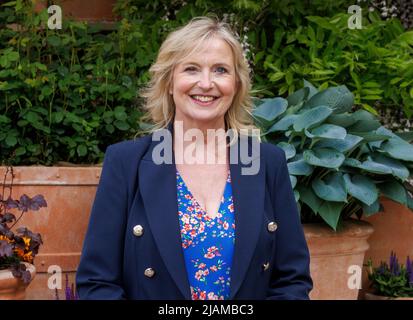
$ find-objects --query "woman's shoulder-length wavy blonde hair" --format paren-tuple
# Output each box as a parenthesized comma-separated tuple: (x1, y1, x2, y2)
(141, 17, 255, 141)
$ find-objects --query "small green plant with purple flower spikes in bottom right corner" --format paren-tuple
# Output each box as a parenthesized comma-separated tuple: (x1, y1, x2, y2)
(366, 252, 413, 297)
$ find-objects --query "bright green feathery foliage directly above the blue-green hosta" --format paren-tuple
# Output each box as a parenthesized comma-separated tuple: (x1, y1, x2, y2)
(261, 10, 413, 117)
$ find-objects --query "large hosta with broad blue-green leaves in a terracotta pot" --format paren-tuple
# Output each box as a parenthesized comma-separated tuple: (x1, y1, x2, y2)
(253, 81, 413, 230)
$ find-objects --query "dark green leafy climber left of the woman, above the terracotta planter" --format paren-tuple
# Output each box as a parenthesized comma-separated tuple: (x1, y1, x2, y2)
(0, 1, 145, 165)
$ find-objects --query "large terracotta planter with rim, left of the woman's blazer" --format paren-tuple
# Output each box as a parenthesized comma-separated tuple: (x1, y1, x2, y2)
(0, 166, 102, 299)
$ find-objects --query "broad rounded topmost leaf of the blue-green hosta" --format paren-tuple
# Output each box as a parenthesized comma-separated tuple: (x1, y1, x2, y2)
(305, 86, 354, 114)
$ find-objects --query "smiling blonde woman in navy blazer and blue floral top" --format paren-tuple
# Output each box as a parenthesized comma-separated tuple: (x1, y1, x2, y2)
(77, 17, 312, 300)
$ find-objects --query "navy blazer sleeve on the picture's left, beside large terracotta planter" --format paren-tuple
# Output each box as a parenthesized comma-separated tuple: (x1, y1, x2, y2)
(76, 146, 127, 300)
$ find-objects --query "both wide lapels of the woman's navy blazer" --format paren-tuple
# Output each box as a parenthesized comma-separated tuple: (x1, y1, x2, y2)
(139, 124, 265, 300)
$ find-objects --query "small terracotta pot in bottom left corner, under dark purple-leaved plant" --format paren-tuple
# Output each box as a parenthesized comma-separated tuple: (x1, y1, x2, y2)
(0, 263, 36, 300)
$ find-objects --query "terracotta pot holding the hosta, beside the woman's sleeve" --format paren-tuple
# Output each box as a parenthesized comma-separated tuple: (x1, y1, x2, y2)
(303, 220, 373, 300)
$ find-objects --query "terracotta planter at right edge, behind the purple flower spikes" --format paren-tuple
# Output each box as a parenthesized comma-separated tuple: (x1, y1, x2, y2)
(361, 198, 413, 297)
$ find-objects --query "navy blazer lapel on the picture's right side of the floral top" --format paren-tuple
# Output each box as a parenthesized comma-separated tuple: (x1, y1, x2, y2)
(230, 138, 265, 300)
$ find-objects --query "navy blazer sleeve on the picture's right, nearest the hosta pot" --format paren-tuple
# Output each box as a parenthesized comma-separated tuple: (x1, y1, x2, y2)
(267, 149, 313, 300)
